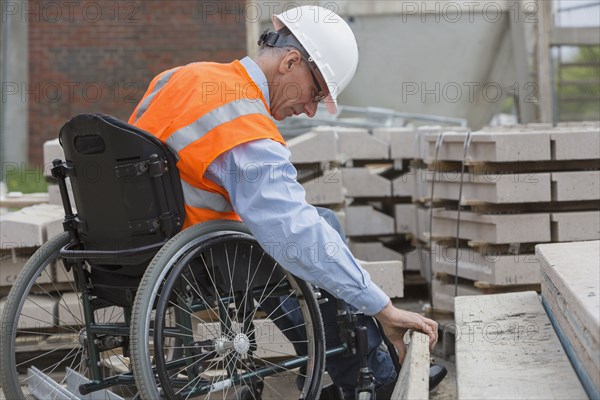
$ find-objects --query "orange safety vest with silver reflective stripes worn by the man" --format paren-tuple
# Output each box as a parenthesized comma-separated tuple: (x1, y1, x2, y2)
(129, 60, 285, 228)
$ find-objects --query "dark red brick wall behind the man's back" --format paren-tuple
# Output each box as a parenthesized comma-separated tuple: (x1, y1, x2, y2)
(27, 0, 246, 163)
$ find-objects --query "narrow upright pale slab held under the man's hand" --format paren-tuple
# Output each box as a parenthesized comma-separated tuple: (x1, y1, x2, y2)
(392, 332, 429, 400)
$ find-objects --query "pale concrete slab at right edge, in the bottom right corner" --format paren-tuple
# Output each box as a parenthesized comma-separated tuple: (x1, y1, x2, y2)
(536, 241, 600, 399)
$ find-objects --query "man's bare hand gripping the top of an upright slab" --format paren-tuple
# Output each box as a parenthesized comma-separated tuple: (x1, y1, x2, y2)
(375, 302, 438, 364)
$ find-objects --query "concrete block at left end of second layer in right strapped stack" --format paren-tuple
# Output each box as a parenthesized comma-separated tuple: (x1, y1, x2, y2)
(427, 172, 552, 204)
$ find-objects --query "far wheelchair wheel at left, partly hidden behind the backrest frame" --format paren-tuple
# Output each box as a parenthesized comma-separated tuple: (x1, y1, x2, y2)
(0, 233, 135, 400)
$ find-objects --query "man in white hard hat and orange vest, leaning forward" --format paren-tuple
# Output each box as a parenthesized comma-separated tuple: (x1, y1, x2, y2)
(129, 7, 437, 398)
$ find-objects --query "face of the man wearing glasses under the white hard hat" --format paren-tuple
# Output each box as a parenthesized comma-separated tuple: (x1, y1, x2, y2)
(271, 51, 327, 121)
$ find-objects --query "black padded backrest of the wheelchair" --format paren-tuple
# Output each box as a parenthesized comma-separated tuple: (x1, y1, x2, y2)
(59, 114, 185, 265)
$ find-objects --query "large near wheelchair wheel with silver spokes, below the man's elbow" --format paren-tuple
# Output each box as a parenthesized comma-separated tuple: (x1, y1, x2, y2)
(131, 221, 325, 400)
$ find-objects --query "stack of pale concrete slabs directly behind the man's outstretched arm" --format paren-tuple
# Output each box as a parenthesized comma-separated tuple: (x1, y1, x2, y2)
(288, 127, 414, 297)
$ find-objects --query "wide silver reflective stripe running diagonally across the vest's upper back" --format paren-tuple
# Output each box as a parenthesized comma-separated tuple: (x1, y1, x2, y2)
(166, 99, 269, 153)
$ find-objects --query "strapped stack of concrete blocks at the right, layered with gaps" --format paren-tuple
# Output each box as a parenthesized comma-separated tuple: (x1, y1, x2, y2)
(424, 124, 600, 311)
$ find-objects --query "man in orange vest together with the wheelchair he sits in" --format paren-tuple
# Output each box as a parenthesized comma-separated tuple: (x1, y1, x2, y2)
(0, 6, 445, 400)
